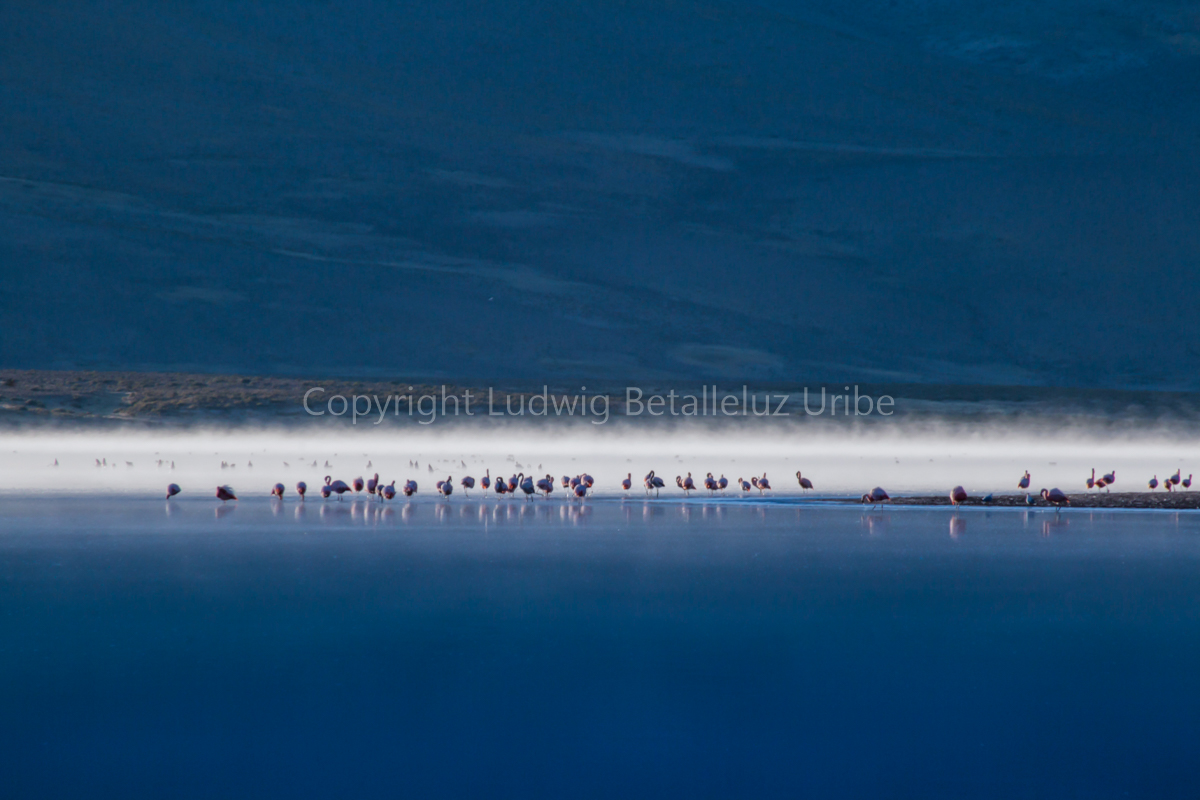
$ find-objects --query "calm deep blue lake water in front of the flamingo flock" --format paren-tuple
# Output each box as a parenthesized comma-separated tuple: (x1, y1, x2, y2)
(0, 498, 1200, 799)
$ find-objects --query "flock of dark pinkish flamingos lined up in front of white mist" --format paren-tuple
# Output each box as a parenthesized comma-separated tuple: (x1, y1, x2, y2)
(167, 462, 1192, 509)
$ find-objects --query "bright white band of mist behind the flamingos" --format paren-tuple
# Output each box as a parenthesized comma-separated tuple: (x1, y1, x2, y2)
(0, 419, 1200, 497)
